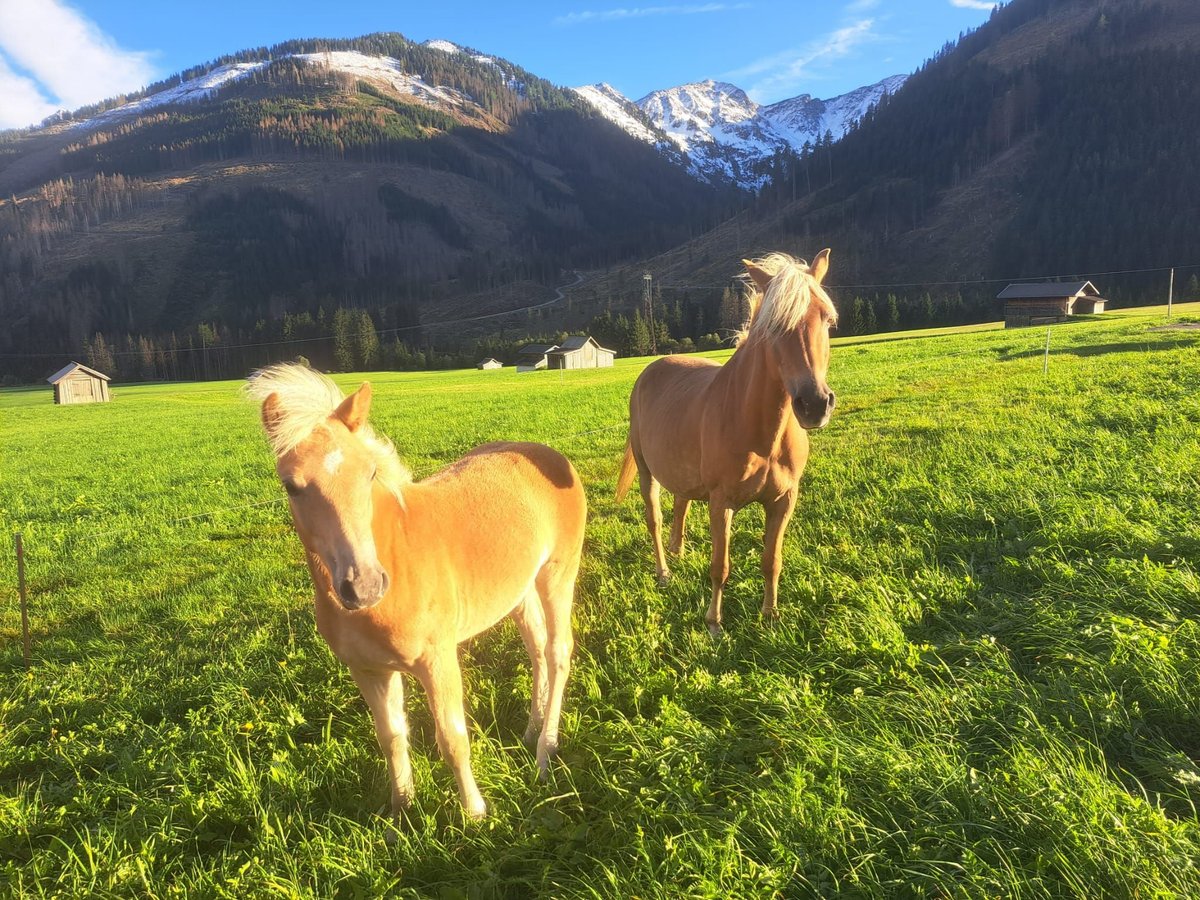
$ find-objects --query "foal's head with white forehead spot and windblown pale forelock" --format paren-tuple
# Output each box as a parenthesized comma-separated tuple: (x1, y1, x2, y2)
(251, 366, 398, 610)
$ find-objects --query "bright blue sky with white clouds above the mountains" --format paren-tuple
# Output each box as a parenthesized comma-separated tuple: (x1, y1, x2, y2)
(0, 0, 992, 127)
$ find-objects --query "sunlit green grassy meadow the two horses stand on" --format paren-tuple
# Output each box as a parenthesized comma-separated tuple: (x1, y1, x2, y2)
(0, 305, 1200, 898)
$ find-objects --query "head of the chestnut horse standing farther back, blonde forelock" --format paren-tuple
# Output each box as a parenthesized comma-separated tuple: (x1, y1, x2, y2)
(742, 250, 838, 430)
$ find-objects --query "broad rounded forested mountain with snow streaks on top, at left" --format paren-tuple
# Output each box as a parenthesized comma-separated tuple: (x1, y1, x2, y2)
(0, 34, 738, 377)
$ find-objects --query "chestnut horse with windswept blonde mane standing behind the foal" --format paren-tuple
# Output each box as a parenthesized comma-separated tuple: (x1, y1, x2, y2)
(617, 250, 838, 635)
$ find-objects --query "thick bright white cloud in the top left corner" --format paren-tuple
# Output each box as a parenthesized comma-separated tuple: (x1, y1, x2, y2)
(0, 0, 155, 124)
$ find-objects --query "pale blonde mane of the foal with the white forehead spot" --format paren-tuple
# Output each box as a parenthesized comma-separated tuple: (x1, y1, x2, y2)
(244, 362, 413, 496)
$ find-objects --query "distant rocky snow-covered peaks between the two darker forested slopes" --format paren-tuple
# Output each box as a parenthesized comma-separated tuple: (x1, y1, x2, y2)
(575, 76, 907, 188)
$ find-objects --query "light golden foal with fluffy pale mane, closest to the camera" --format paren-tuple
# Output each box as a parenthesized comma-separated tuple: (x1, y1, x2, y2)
(247, 365, 587, 818)
